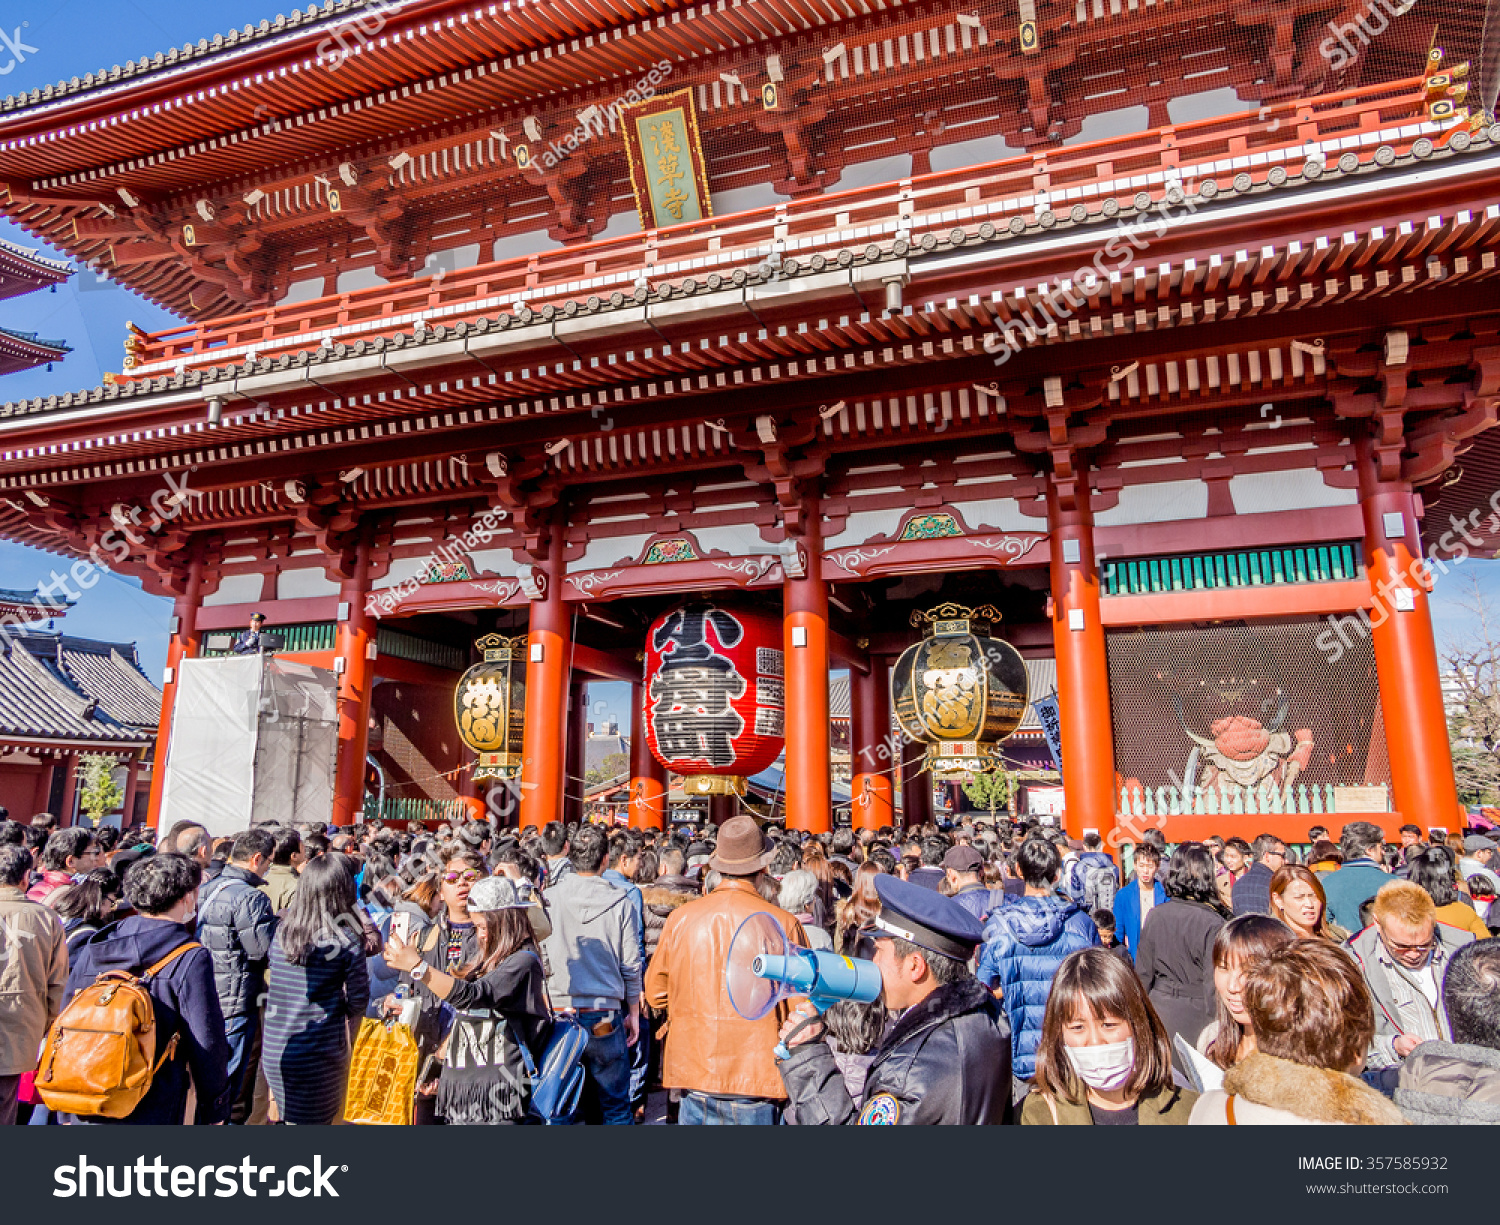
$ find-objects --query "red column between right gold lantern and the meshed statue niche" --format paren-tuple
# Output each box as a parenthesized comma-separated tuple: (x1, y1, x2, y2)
(1047, 478, 1115, 838)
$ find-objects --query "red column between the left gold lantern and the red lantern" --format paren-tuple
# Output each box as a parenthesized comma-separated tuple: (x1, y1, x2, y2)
(521, 516, 573, 829)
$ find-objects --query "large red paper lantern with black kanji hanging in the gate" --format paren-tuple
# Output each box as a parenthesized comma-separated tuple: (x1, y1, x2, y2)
(645, 603, 786, 795)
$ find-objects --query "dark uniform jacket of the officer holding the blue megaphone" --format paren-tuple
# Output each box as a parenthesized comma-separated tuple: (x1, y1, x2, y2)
(777, 978, 1011, 1125)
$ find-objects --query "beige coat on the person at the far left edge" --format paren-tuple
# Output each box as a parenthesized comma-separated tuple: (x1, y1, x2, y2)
(0, 888, 68, 1077)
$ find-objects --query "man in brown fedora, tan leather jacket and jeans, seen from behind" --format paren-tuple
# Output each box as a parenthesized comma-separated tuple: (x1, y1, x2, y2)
(645, 817, 807, 1125)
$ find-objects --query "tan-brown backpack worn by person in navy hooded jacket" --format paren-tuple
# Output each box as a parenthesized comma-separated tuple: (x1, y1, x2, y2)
(36, 940, 203, 1119)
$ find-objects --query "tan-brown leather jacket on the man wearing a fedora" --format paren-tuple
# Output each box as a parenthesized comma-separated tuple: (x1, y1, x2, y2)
(645, 877, 807, 1099)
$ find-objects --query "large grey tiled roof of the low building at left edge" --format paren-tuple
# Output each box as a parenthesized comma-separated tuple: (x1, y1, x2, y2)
(0, 630, 161, 745)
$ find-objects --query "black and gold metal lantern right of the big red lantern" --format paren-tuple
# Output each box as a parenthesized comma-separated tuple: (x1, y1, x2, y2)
(891, 604, 1031, 777)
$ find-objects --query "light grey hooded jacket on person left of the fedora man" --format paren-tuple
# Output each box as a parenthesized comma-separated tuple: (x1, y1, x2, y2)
(543, 871, 641, 1009)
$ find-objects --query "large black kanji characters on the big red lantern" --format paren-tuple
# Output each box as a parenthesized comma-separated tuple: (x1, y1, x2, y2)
(650, 607, 746, 768)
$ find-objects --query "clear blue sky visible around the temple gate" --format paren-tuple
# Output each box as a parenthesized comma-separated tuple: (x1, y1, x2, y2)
(0, 0, 1500, 689)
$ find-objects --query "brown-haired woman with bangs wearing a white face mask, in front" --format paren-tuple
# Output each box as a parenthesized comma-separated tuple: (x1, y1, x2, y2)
(1022, 948, 1197, 1126)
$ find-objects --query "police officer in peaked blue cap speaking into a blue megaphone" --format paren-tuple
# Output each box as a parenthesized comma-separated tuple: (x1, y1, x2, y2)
(777, 874, 1011, 1125)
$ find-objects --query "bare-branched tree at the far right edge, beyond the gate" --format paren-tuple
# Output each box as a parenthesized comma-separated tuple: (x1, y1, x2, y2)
(1439, 574, 1500, 804)
